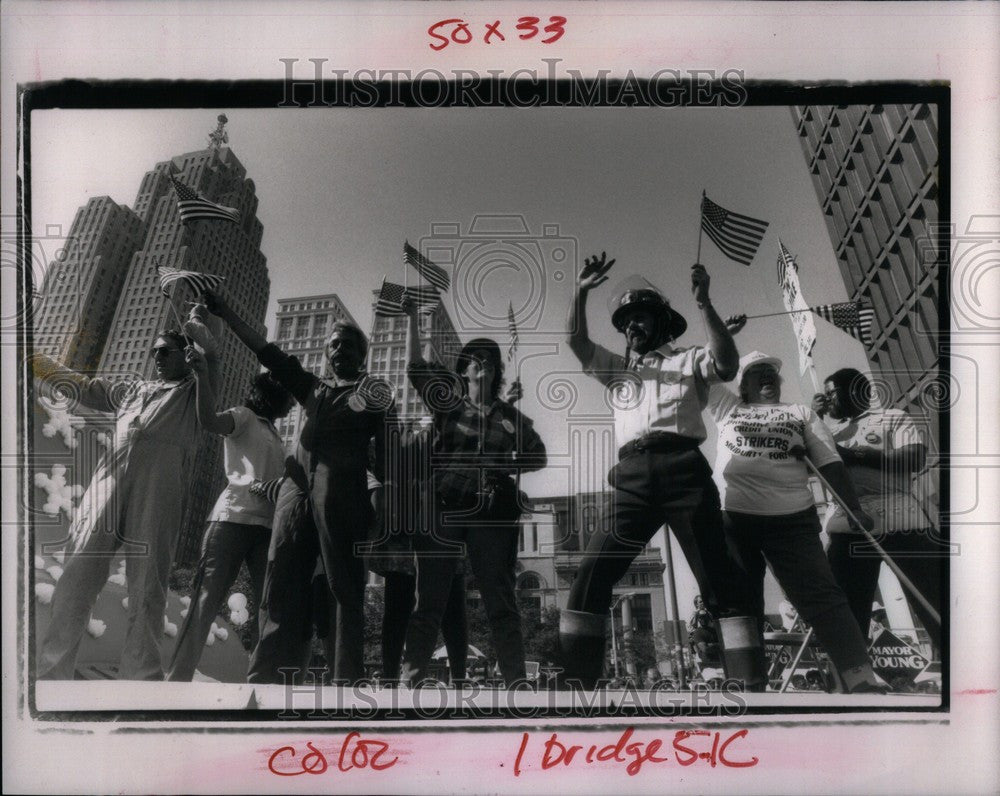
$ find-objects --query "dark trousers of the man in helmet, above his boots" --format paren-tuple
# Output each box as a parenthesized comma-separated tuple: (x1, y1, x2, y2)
(566, 448, 748, 617)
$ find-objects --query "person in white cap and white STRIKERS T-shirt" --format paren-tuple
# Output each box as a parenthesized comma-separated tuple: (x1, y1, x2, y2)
(708, 346, 879, 693)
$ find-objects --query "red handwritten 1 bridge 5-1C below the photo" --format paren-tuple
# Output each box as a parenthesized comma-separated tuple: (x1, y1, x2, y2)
(514, 727, 757, 777)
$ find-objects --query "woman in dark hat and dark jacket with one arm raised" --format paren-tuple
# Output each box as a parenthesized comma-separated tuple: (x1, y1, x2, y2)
(401, 302, 546, 685)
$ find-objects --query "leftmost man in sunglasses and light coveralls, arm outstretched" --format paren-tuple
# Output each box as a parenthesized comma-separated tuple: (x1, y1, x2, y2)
(31, 324, 213, 680)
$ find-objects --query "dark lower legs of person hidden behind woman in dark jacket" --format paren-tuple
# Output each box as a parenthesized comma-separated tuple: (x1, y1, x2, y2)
(382, 571, 469, 682)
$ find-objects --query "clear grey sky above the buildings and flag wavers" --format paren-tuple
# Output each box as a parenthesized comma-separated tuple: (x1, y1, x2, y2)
(31, 106, 867, 613)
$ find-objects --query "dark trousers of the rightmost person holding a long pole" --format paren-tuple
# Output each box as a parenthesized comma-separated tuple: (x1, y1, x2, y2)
(827, 530, 945, 649)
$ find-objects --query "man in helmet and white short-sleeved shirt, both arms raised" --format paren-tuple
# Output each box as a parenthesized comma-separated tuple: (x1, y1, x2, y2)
(559, 253, 766, 687)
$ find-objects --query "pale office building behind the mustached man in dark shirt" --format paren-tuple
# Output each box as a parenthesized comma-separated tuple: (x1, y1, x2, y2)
(275, 293, 357, 453)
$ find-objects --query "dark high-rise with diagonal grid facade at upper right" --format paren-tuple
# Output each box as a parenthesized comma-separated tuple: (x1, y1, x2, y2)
(792, 104, 941, 451)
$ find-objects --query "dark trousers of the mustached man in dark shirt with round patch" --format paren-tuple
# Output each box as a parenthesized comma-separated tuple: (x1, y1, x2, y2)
(248, 466, 371, 683)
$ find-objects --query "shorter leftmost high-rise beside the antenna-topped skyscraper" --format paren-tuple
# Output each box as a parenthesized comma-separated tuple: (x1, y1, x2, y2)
(33, 196, 146, 372)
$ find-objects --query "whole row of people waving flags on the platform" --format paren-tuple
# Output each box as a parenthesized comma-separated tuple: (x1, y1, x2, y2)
(33, 254, 941, 693)
